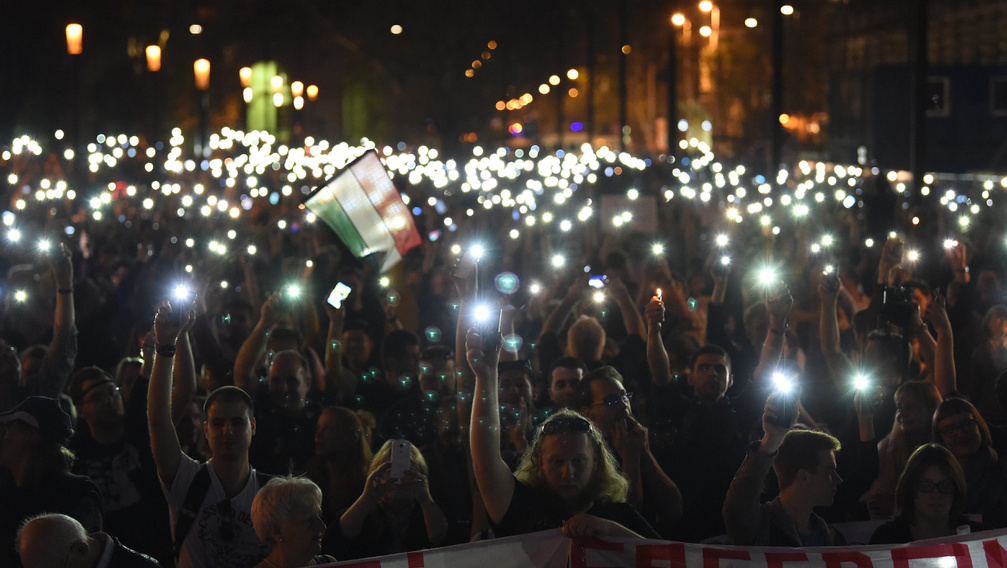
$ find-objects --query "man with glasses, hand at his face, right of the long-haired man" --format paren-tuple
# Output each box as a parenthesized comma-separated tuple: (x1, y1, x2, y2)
(577, 366, 682, 538)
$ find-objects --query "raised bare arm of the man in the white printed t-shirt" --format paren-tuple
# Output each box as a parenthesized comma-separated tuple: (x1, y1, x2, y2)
(147, 302, 192, 487)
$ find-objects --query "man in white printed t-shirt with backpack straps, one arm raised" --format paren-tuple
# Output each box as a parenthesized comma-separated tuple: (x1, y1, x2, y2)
(147, 302, 269, 568)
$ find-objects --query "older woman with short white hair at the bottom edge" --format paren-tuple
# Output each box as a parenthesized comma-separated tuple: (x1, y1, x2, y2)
(252, 477, 335, 568)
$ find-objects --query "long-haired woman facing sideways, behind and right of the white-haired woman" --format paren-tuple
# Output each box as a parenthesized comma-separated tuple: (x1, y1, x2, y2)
(307, 406, 374, 525)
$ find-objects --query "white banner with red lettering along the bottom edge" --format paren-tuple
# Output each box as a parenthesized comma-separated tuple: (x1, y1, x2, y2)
(326, 529, 1007, 568)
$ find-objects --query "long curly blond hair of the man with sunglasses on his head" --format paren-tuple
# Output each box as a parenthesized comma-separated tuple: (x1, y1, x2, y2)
(514, 409, 629, 503)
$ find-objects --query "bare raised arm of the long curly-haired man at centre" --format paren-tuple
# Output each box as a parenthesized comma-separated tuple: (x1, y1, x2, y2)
(465, 329, 515, 523)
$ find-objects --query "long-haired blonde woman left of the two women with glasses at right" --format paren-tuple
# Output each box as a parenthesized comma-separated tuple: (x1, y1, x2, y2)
(864, 381, 941, 519)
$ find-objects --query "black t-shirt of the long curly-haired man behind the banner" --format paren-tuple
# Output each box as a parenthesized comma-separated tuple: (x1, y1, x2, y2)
(492, 478, 661, 539)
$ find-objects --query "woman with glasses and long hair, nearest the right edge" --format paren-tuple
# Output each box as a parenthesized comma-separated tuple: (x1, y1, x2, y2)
(933, 398, 1007, 529)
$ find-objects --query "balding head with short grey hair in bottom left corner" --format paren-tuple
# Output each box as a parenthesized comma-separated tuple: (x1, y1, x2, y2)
(17, 513, 89, 568)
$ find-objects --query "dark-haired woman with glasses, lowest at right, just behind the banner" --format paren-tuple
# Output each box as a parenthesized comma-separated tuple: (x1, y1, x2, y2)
(870, 444, 987, 544)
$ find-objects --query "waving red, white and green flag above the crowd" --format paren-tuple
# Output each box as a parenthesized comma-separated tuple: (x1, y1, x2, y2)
(303, 150, 421, 272)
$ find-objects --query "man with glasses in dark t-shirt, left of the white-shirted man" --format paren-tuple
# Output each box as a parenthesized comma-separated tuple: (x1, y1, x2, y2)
(69, 367, 172, 564)
